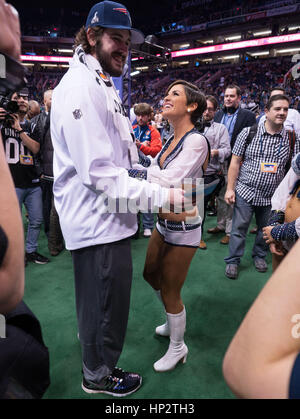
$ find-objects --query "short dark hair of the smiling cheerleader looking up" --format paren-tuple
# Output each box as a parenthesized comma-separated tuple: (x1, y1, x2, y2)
(166, 80, 207, 125)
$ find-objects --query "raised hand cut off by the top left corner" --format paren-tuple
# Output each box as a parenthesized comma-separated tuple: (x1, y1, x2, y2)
(0, 0, 21, 61)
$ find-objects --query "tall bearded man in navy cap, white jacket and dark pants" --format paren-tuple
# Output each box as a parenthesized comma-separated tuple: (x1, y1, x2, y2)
(51, 1, 183, 396)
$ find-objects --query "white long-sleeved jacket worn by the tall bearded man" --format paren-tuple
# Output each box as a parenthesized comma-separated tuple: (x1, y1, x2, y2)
(51, 47, 168, 250)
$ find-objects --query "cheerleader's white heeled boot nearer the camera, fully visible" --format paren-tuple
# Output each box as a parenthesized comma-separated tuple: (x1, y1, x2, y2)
(153, 308, 188, 372)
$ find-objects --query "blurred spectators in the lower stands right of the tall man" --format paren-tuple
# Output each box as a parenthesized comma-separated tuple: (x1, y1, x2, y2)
(132, 57, 300, 114)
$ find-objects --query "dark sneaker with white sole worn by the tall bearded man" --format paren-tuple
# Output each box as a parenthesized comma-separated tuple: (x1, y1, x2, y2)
(81, 368, 142, 397)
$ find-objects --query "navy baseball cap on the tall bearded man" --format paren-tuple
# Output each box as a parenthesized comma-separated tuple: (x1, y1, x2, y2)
(85, 0, 144, 44)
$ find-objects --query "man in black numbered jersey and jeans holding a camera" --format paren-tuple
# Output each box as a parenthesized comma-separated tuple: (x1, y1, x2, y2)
(0, 89, 49, 264)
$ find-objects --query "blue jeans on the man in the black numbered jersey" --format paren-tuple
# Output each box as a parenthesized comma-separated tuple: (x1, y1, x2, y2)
(16, 186, 43, 253)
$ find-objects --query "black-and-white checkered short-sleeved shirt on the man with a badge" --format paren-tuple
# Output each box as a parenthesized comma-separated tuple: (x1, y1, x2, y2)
(232, 124, 300, 206)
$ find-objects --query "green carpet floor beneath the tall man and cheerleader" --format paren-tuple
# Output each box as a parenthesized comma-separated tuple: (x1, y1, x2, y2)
(24, 217, 271, 399)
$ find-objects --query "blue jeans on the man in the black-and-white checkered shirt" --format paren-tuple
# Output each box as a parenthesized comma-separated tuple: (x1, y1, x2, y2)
(224, 193, 271, 265)
